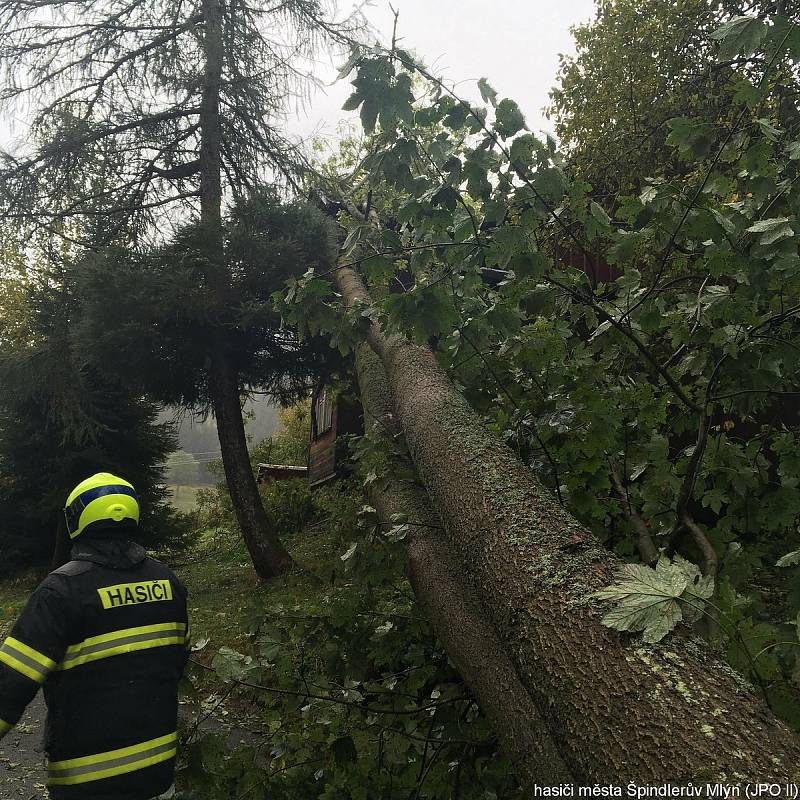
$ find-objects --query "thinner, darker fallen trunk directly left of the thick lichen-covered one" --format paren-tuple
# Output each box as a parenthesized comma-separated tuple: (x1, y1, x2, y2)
(356, 344, 572, 794)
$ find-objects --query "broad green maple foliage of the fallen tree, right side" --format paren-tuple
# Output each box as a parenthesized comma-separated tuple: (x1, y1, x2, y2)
(286, 4, 800, 724)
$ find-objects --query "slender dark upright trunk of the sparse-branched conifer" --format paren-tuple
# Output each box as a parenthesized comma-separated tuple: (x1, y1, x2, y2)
(199, 0, 292, 579)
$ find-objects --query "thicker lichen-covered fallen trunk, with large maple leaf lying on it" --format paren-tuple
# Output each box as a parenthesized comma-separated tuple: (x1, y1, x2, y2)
(335, 268, 800, 784)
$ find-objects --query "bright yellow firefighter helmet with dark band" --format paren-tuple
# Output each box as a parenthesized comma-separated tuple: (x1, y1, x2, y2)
(64, 472, 139, 539)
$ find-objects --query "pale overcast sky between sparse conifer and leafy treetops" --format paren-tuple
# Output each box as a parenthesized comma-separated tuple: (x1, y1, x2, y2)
(0, 0, 594, 152)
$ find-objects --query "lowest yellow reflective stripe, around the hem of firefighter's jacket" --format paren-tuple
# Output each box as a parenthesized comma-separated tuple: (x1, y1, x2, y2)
(47, 733, 178, 786)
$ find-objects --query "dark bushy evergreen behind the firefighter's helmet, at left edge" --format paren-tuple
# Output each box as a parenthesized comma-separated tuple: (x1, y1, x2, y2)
(0, 250, 183, 568)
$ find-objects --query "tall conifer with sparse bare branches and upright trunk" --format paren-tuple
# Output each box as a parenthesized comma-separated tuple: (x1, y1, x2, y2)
(0, 0, 354, 577)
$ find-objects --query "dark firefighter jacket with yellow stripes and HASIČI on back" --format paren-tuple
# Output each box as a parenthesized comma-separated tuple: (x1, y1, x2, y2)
(0, 539, 188, 800)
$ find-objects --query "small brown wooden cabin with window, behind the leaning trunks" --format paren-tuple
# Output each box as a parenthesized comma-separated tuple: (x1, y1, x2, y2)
(308, 389, 364, 488)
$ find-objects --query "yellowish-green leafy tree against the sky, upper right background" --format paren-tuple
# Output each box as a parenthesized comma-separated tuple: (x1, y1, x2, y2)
(549, 0, 798, 202)
